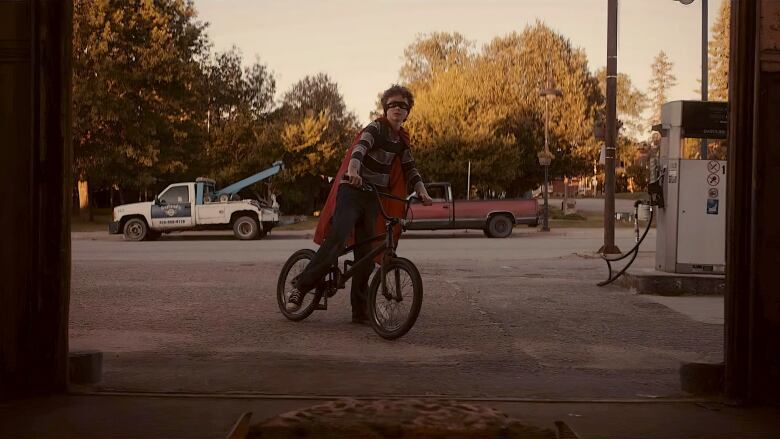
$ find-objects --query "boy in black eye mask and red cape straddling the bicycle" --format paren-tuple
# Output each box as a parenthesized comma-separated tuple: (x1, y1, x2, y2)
(286, 85, 432, 323)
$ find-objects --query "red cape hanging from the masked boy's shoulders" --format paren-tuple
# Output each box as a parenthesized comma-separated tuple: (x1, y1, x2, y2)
(314, 118, 410, 262)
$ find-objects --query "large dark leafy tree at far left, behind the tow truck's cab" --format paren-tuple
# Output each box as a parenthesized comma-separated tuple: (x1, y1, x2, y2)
(73, 0, 207, 218)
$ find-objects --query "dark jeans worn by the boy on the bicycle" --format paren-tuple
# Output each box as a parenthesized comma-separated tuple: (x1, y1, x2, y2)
(296, 184, 379, 314)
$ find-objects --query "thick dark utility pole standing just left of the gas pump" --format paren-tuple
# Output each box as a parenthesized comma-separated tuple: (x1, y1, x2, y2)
(599, 0, 620, 255)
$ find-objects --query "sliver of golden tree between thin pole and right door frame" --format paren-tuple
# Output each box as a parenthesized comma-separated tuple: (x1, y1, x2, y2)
(708, 0, 731, 101)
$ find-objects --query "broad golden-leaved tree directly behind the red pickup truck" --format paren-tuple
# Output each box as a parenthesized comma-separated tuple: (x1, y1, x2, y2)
(407, 23, 603, 196)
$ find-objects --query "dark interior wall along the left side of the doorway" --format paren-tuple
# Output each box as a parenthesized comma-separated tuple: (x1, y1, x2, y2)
(0, 0, 72, 396)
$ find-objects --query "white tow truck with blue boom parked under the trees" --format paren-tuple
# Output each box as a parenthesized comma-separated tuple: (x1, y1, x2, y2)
(108, 161, 283, 241)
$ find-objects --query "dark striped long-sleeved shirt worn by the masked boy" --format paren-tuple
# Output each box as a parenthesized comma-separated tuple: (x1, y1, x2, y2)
(352, 120, 422, 189)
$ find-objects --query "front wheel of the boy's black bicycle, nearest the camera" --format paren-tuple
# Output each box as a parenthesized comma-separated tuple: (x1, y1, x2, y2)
(367, 258, 423, 340)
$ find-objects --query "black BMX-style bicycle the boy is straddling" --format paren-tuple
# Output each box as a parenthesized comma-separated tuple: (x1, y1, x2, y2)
(276, 184, 423, 340)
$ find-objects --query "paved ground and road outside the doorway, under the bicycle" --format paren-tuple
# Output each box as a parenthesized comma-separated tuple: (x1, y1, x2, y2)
(70, 228, 723, 398)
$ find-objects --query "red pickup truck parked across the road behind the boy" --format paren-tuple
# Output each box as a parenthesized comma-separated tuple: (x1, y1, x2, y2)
(407, 183, 539, 238)
